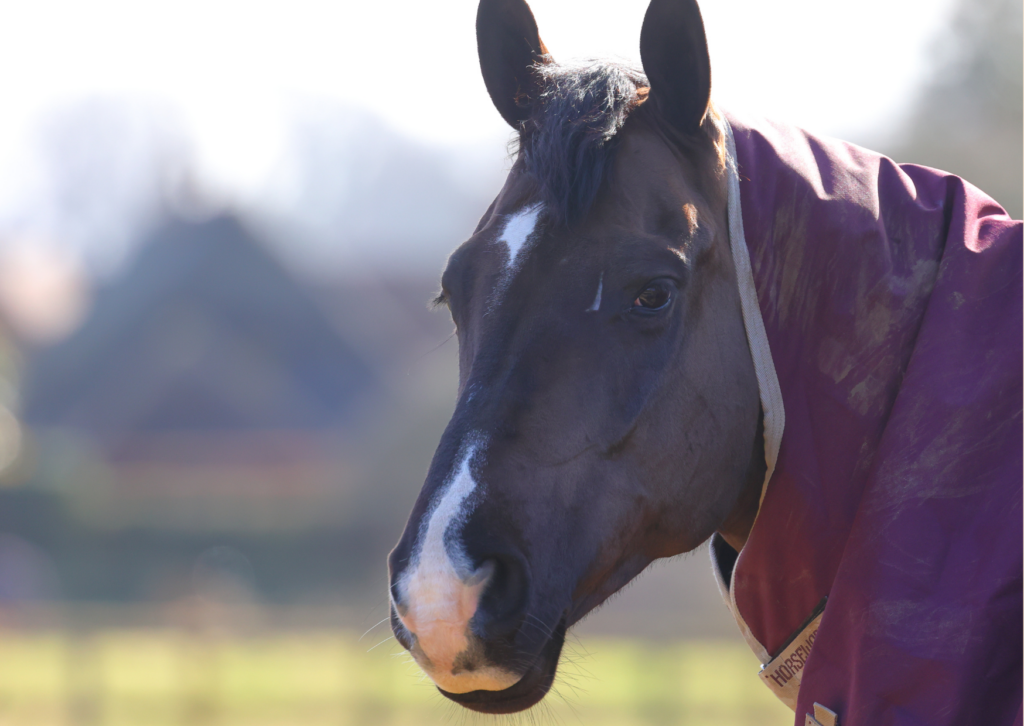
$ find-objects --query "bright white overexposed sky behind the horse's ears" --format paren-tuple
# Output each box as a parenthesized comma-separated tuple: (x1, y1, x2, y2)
(0, 0, 950, 198)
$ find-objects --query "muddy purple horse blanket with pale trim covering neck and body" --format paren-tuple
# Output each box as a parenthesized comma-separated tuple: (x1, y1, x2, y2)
(712, 111, 1024, 726)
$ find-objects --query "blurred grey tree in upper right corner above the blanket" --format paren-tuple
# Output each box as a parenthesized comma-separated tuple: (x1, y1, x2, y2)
(876, 0, 1024, 219)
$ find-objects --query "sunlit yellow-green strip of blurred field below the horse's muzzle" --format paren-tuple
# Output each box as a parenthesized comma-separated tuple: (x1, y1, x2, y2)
(0, 630, 793, 726)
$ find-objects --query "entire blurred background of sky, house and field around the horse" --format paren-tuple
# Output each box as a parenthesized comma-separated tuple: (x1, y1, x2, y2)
(0, 0, 1022, 726)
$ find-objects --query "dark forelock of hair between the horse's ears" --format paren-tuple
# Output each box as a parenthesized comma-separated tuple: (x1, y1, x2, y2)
(519, 61, 647, 226)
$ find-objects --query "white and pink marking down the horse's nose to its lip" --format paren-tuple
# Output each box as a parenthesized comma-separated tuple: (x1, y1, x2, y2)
(398, 436, 519, 693)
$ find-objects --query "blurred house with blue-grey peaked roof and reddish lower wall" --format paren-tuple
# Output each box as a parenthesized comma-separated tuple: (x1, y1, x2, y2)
(22, 211, 377, 530)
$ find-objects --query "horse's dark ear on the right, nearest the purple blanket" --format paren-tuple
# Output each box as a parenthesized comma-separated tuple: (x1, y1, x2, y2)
(640, 0, 711, 133)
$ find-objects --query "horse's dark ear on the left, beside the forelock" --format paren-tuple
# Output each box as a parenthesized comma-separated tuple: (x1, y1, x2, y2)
(476, 0, 548, 129)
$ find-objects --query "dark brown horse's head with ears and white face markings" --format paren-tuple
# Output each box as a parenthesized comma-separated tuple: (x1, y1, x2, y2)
(389, 0, 764, 713)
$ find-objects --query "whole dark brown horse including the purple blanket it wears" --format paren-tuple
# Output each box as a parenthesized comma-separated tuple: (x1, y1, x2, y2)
(388, 0, 1022, 726)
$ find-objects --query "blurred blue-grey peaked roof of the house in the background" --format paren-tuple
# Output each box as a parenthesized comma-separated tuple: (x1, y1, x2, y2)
(22, 211, 377, 434)
